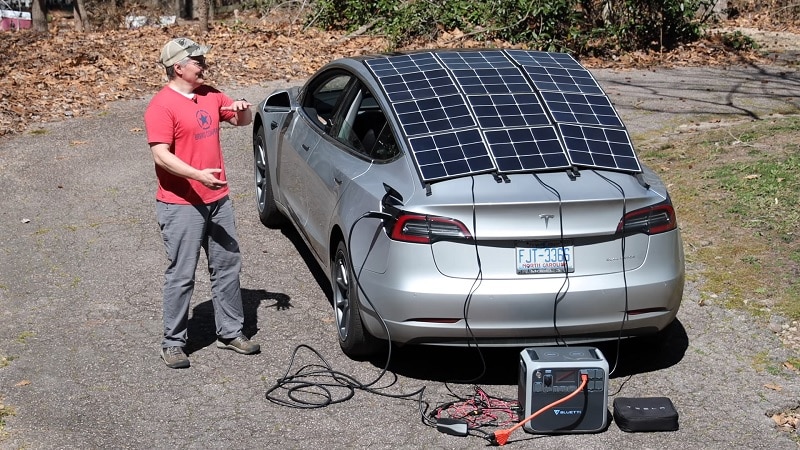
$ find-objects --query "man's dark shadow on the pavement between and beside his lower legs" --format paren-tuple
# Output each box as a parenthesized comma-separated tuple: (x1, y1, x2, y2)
(184, 289, 272, 355)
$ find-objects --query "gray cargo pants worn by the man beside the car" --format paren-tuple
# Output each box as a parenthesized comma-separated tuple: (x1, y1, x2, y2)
(156, 197, 244, 347)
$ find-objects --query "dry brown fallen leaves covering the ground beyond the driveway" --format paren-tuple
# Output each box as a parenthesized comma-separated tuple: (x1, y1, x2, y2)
(0, 13, 788, 136)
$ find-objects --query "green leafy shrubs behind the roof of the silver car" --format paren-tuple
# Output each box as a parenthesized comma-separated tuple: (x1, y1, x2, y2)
(309, 0, 714, 54)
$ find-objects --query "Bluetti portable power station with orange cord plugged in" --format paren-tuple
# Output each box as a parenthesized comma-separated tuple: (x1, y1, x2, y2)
(518, 347, 608, 434)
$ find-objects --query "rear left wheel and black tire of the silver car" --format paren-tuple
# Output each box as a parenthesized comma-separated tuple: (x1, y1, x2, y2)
(331, 241, 379, 359)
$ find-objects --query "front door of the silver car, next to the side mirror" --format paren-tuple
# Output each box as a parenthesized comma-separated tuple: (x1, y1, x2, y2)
(277, 71, 352, 235)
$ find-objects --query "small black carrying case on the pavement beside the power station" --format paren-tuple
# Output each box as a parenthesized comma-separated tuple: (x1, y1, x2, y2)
(614, 397, 678, 433)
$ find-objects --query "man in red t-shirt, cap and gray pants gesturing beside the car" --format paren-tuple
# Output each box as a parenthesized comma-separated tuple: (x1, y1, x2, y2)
(144, 38, 260, 369)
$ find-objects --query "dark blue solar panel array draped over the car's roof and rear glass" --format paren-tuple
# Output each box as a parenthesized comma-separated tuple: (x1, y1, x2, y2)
(366, 50, 641, 182)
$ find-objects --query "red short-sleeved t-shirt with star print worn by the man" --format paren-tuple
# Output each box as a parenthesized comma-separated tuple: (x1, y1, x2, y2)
(144, 86, 236, 205)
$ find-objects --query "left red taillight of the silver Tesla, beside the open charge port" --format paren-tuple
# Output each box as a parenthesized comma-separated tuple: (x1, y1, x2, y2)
(389, 213, 472, 244)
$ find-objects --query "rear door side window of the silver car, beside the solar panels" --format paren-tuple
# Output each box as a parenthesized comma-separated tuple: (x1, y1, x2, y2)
(336, 86, 399, 160)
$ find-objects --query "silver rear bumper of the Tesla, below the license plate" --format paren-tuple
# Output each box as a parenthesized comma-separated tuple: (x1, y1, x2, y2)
(360, 233, 684, 346)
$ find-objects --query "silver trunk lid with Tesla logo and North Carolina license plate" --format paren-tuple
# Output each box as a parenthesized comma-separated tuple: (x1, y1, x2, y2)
(416, 171, 665, 279)
